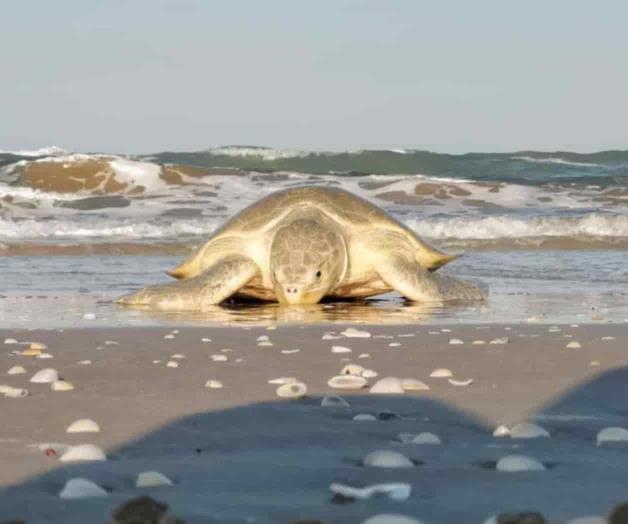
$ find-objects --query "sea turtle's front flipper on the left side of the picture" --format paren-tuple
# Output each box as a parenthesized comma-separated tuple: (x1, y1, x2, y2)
(117, 255, 259, 311)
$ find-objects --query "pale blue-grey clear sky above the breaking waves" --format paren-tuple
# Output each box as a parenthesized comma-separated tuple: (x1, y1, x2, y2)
(0, 0, 628, 152)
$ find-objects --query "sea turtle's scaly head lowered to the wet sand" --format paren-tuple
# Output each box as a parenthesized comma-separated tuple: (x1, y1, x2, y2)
(270, 219, 347, 304)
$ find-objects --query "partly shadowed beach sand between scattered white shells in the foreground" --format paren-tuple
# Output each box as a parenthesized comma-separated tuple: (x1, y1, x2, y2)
(0, 324, 628, 524)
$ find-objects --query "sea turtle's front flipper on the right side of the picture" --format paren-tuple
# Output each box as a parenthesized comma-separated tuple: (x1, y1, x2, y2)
(378, 254, 485, 303)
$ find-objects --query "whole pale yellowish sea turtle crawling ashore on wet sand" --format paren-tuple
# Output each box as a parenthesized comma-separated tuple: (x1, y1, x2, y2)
(118, 187, 484, 311)
